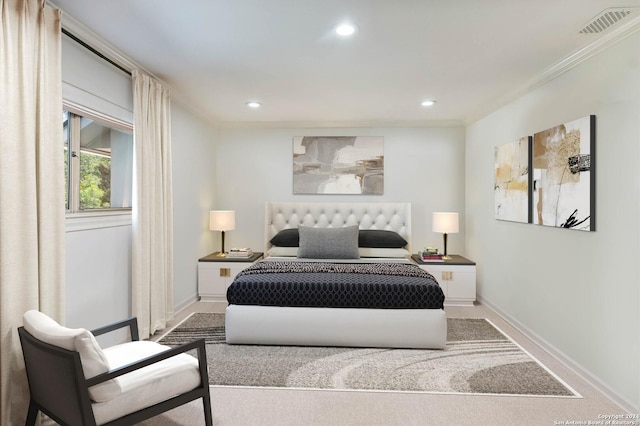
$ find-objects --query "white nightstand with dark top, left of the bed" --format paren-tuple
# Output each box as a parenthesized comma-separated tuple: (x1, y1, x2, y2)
(198, 252, 262, 302)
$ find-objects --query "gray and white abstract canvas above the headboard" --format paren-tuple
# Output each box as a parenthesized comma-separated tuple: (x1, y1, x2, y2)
(293, 136, 384, 195)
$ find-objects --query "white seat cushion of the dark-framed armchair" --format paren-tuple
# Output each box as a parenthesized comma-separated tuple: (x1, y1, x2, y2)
(92, 340, 200, 424)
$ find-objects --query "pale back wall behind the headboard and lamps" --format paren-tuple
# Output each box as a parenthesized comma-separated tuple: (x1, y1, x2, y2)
(215, 127, 465, 254)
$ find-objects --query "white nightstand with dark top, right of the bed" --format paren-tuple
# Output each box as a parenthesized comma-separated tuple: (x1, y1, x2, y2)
(411, 254, 476, 306)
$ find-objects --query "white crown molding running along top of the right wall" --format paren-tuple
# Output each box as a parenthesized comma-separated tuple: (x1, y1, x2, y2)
(464, 14, 640, 125)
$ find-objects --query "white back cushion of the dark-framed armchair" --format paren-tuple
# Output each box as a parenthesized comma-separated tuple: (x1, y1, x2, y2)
(22, 310, 121, 402)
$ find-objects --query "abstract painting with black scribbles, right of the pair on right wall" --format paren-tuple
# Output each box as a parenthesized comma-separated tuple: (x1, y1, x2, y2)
(531, 115, 596, 231)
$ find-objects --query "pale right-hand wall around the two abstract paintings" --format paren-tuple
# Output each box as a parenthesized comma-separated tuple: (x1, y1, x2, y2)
(466, 34, 640, 412)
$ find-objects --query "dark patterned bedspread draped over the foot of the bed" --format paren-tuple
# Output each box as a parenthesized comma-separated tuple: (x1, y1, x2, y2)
(227, 261, 444, 309)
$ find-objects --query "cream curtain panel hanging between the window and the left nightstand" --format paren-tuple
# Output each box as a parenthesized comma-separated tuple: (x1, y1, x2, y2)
(131, 70, 173, 338)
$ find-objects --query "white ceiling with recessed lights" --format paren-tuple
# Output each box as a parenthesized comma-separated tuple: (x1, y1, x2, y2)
(48, 0, 640, 125)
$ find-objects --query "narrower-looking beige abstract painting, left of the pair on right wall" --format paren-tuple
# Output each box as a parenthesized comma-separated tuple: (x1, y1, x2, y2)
(494, 136, 531, 223)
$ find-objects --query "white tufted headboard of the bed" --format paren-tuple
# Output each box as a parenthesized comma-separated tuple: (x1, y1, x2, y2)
(264, 202, 411, 253)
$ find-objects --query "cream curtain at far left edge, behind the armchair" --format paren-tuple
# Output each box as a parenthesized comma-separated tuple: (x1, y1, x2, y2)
(0, 0, 65, 425)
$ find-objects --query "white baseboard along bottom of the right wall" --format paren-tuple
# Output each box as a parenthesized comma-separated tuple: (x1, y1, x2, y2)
(478, 297, 640, 414)
